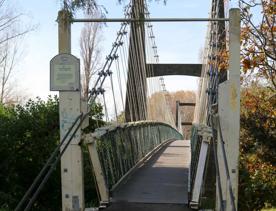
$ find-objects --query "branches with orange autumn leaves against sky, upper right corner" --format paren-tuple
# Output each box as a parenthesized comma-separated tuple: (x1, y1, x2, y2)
(240, 0, 276, 90)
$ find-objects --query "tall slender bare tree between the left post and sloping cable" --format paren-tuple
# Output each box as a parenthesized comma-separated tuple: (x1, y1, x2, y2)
(80, 11, 102, 98)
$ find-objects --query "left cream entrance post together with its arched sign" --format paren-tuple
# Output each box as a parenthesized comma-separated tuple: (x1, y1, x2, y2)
(54, 10, 84, 211)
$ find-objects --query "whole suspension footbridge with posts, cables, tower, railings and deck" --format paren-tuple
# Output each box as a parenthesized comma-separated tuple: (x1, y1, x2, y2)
(16, 0, 240, 211)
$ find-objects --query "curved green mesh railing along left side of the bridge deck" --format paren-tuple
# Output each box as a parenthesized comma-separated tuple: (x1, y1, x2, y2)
(86, 121, 183, 190)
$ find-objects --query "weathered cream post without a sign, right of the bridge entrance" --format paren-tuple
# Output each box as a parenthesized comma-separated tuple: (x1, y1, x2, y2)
(217, 8, 240, 210)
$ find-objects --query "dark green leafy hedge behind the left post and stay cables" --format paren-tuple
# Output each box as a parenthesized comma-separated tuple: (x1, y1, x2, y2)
(0, 97, 105, 211)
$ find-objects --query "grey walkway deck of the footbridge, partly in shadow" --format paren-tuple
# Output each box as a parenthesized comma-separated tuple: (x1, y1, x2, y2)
(108, 140, 190, 210)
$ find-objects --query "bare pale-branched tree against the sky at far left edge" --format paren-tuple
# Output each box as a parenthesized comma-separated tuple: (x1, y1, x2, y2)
(0, 0, 31, 103)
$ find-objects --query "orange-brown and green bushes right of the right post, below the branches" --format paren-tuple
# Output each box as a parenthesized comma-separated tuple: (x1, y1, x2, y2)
(239, 84, 276, 210)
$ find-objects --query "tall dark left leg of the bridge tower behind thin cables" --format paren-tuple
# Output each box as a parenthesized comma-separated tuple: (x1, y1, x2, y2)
(125, 0, 147, 122)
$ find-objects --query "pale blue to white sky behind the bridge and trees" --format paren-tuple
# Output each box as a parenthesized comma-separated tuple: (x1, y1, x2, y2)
(10, 0, 211, 99)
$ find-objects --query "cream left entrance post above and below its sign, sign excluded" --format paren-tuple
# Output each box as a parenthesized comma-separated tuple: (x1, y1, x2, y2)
(58, 10, 84, 211)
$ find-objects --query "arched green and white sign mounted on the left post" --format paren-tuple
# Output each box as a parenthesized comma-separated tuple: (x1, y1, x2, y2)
(50, 54, 80, 91)
